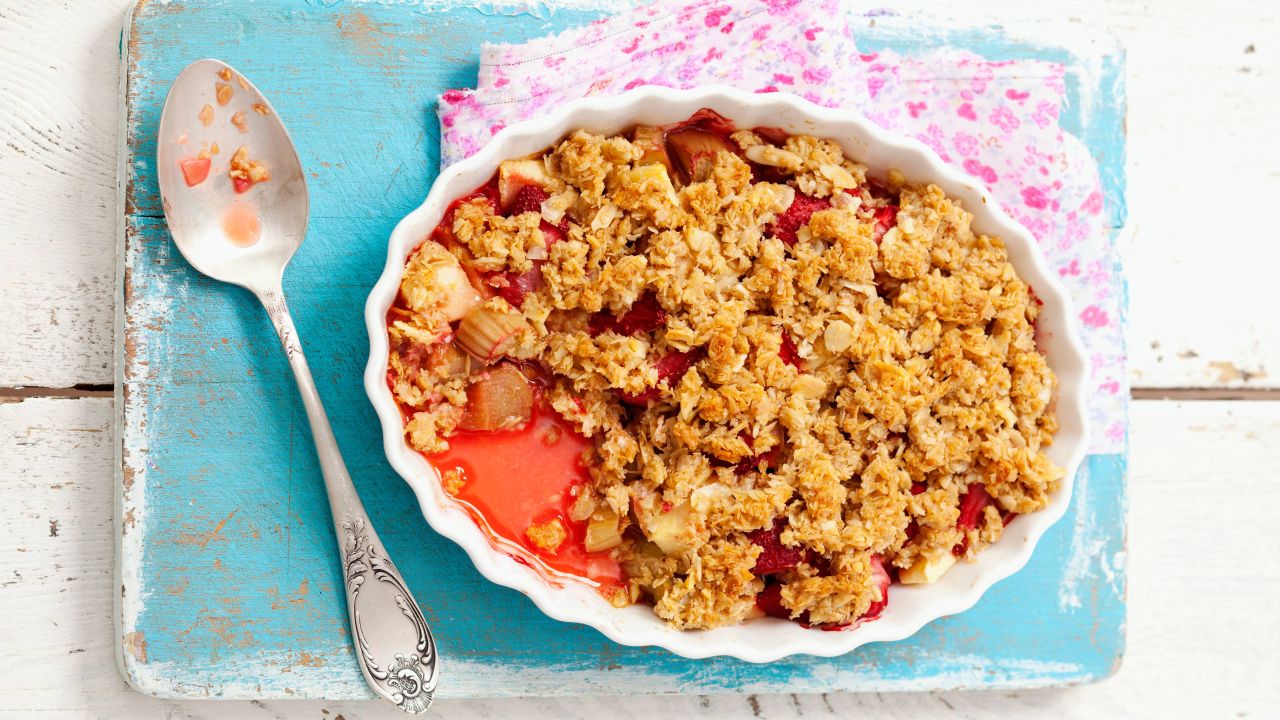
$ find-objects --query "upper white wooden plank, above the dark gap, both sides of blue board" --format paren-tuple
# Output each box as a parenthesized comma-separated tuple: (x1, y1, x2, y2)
(0, 0, 1280, 388)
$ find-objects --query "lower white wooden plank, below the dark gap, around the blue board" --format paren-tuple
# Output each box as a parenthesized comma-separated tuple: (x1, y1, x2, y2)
(0, 398, 1280, 720)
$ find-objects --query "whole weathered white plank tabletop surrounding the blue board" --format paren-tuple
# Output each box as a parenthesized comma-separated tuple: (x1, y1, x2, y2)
(0, 0, 1280, 720)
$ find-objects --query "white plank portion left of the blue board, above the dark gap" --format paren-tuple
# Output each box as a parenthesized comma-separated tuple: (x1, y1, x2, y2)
(0, 0, 127, 387)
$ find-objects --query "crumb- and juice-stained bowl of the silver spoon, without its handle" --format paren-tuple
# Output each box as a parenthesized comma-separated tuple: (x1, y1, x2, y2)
(156, 60, 310, 292)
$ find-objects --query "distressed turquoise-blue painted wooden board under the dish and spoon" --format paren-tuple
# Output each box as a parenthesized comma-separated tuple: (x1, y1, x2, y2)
(116, 0, 1125, 698)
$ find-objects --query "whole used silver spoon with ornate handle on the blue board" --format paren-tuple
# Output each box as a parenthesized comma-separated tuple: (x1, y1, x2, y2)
(156, 60, 439, 714)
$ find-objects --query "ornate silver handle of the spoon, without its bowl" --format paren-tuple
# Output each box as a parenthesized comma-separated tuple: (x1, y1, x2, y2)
(259, 287, 439, 715)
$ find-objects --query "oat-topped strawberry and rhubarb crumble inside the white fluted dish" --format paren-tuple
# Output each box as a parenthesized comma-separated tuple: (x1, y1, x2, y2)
(388, 109, 1061, 629)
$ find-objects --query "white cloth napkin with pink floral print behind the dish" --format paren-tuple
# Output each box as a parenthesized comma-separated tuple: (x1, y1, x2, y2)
(439, 0, 1129, 454)
